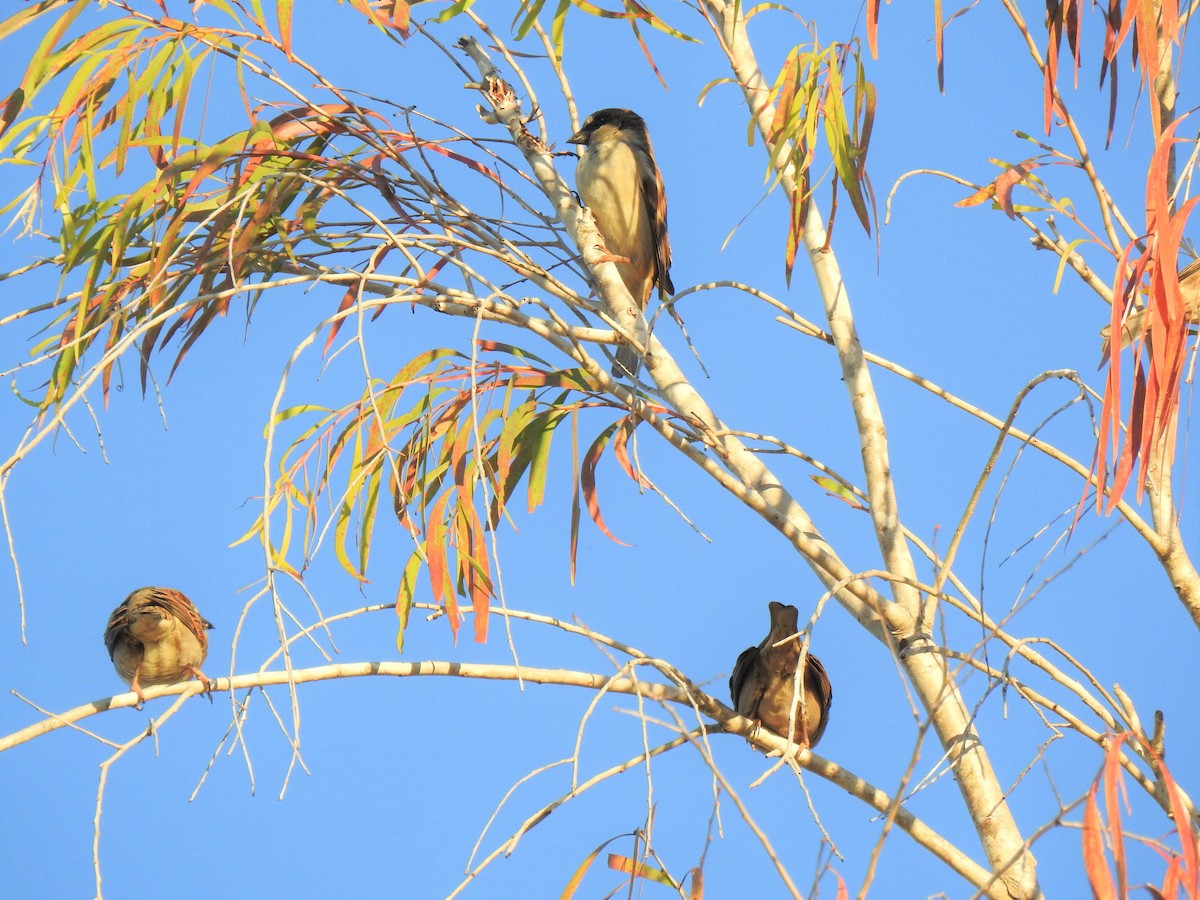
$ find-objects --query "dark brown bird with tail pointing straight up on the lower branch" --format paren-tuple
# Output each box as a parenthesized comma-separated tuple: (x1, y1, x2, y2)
(730, 600, 833, 748)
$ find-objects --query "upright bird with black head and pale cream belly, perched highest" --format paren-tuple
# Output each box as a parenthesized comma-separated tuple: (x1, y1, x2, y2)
(566, 108, 674, 378)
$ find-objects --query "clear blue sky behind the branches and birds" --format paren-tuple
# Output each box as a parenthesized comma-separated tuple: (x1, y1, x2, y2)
(0, 4, 1200, 898)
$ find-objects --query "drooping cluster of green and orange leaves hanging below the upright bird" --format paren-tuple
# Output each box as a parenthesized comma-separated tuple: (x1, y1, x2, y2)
(240, 342, 681, 644)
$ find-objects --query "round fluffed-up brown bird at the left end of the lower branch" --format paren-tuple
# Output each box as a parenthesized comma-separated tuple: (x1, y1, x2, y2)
(104, 588, 212, 707)
